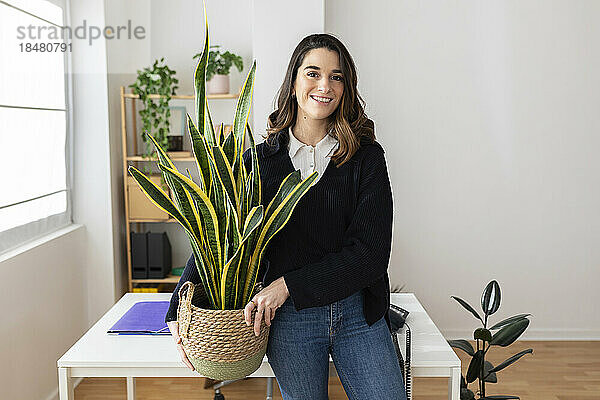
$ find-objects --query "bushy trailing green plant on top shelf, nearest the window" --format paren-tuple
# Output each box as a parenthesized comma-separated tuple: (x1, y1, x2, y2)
(129, 57, 179, 158)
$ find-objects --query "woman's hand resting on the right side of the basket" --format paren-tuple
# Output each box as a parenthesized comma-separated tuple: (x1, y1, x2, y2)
(244, 276, 290, 336)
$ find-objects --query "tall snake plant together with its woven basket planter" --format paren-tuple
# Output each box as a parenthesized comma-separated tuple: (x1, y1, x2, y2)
(129, 3, 317, 380)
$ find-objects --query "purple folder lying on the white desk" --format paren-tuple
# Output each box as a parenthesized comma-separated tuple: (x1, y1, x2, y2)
(107, 301, 171, 335)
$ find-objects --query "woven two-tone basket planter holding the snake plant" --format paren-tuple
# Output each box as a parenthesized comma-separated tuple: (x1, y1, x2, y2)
(177, 282, 269, 380)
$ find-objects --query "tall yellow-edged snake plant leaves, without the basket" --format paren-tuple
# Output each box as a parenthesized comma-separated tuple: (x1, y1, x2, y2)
(128, 9, 317, 310)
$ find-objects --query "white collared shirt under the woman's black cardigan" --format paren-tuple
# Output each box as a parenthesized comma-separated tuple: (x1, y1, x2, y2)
(288, 128, 339, 183)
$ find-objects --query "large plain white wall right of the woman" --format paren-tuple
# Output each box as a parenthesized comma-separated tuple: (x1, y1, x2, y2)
(325, 0, 600, 339)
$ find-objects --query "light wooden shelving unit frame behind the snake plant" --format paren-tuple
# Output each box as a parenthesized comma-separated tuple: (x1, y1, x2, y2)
(120, 86, 239, 292)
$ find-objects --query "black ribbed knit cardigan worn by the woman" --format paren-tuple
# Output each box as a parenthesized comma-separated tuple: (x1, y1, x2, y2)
(165, 130, 393, 330)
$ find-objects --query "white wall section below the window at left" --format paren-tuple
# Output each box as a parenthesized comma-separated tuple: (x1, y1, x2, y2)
(0, 226, 88, 400)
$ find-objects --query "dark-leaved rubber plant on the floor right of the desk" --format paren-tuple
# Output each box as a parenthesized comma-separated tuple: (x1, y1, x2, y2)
(448, 280, 533, 400)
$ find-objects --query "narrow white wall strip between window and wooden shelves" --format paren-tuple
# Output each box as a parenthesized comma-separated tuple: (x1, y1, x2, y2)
(71, 0, 121, 326)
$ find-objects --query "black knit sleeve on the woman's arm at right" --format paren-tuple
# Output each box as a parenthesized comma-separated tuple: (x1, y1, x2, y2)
(283, 144, 393, 310)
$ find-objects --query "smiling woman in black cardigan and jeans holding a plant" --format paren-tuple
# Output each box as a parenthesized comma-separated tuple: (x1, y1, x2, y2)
(166, 34, 406, 400)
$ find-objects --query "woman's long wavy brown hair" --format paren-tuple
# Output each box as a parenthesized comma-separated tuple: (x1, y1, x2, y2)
(266, 33, 375, 167)
